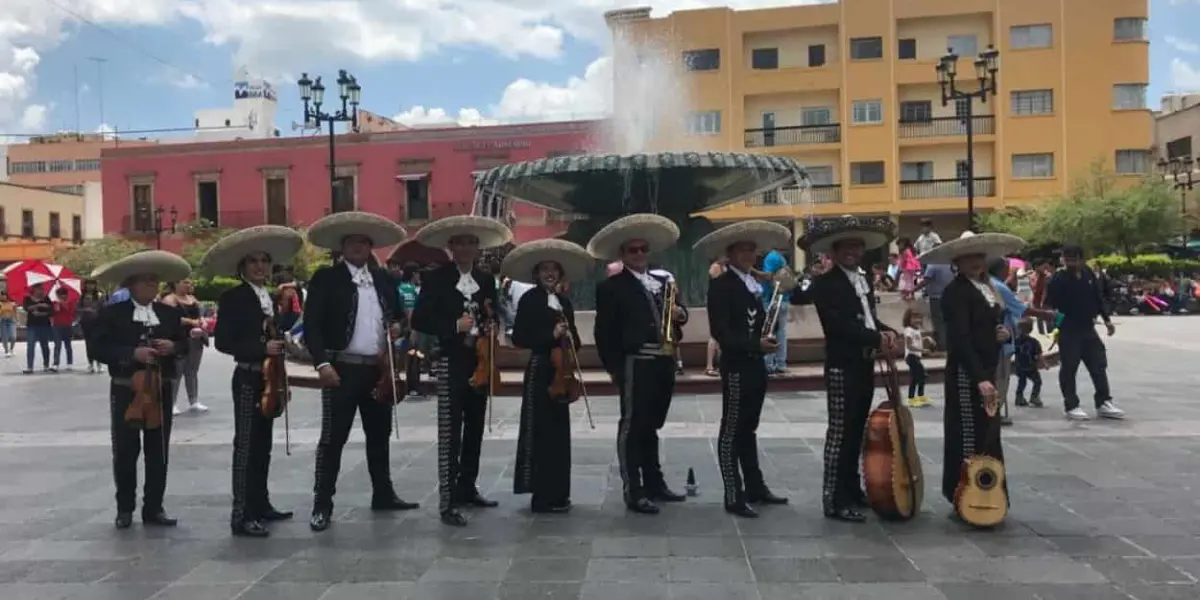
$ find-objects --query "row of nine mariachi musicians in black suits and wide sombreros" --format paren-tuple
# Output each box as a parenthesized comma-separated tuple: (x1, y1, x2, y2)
(84, 212, 1020, 538)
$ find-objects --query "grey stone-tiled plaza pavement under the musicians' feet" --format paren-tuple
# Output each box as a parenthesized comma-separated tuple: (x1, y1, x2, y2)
(0, 317, 1200, 600)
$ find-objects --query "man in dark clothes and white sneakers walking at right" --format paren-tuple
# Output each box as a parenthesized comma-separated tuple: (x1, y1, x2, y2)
(1045, 245, 1124, 421)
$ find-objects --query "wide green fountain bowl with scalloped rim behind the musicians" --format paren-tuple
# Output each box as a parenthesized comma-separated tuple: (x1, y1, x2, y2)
(476, 152, 805, 217)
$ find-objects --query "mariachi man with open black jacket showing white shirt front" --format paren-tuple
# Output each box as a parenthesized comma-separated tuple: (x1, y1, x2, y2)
(304, 211, 418, 532)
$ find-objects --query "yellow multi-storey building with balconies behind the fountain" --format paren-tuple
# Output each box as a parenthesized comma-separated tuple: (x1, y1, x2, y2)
(606, 0, 1153, 238)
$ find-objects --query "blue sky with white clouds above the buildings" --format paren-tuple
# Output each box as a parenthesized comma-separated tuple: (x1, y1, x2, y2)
(0, 0, 1200, 138)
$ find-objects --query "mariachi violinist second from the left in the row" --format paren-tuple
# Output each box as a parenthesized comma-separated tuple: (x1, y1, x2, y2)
(200, 226, 304, 538)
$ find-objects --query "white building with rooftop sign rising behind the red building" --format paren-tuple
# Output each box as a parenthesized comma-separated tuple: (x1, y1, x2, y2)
(194, 67, 280, 142)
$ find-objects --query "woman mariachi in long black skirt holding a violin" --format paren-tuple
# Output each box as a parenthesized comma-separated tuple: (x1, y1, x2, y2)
(502, 239, 593, 512)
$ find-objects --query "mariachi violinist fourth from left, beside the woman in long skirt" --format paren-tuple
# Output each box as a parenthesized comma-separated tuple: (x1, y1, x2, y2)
(413, 215, 512, 527)
